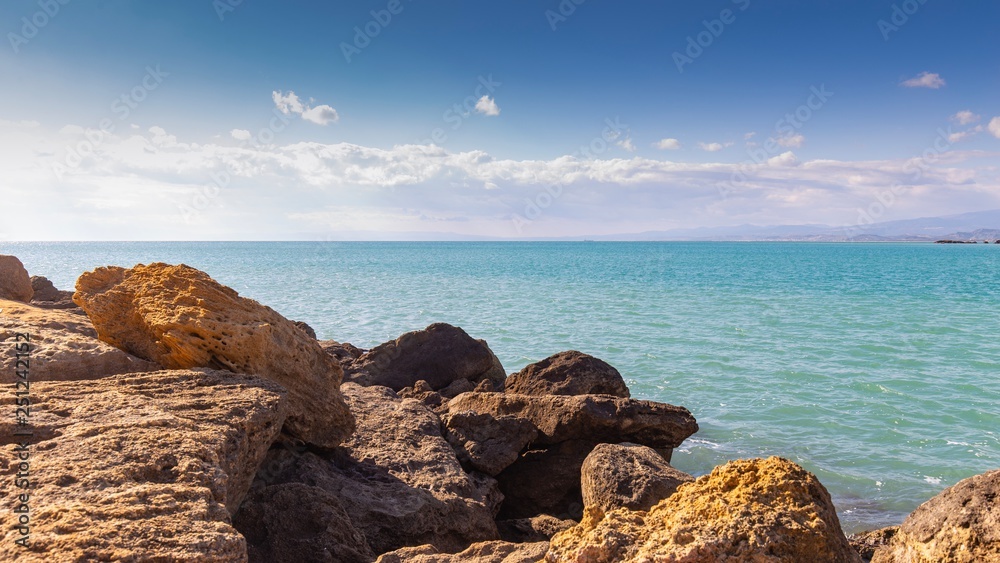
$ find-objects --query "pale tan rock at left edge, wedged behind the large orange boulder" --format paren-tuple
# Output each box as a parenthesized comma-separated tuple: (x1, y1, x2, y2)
(0, 300, 163, 383)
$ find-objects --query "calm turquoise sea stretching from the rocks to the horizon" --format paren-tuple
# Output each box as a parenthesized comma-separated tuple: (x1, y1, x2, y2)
(0, 243, 1000, 532)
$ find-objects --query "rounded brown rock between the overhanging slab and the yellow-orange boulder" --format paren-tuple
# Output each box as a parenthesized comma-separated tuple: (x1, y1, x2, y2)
(580, 443, 694, 512)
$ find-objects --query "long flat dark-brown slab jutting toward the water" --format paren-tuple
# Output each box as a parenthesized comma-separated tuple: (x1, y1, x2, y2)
(448, 393, 698, 448)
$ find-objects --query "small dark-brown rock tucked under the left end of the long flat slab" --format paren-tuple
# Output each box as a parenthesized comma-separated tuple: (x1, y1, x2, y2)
(441, 411, 538, 477)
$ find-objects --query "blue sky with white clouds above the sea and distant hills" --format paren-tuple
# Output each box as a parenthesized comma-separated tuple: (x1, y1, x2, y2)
(0, 0, 1000, 240)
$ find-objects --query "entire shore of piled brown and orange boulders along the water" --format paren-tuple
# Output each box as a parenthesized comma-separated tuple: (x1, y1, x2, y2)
(0, 256, 1000, 563)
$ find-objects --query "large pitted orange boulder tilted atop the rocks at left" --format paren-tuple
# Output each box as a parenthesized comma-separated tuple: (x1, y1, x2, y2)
(73, 263, 354, 447)
